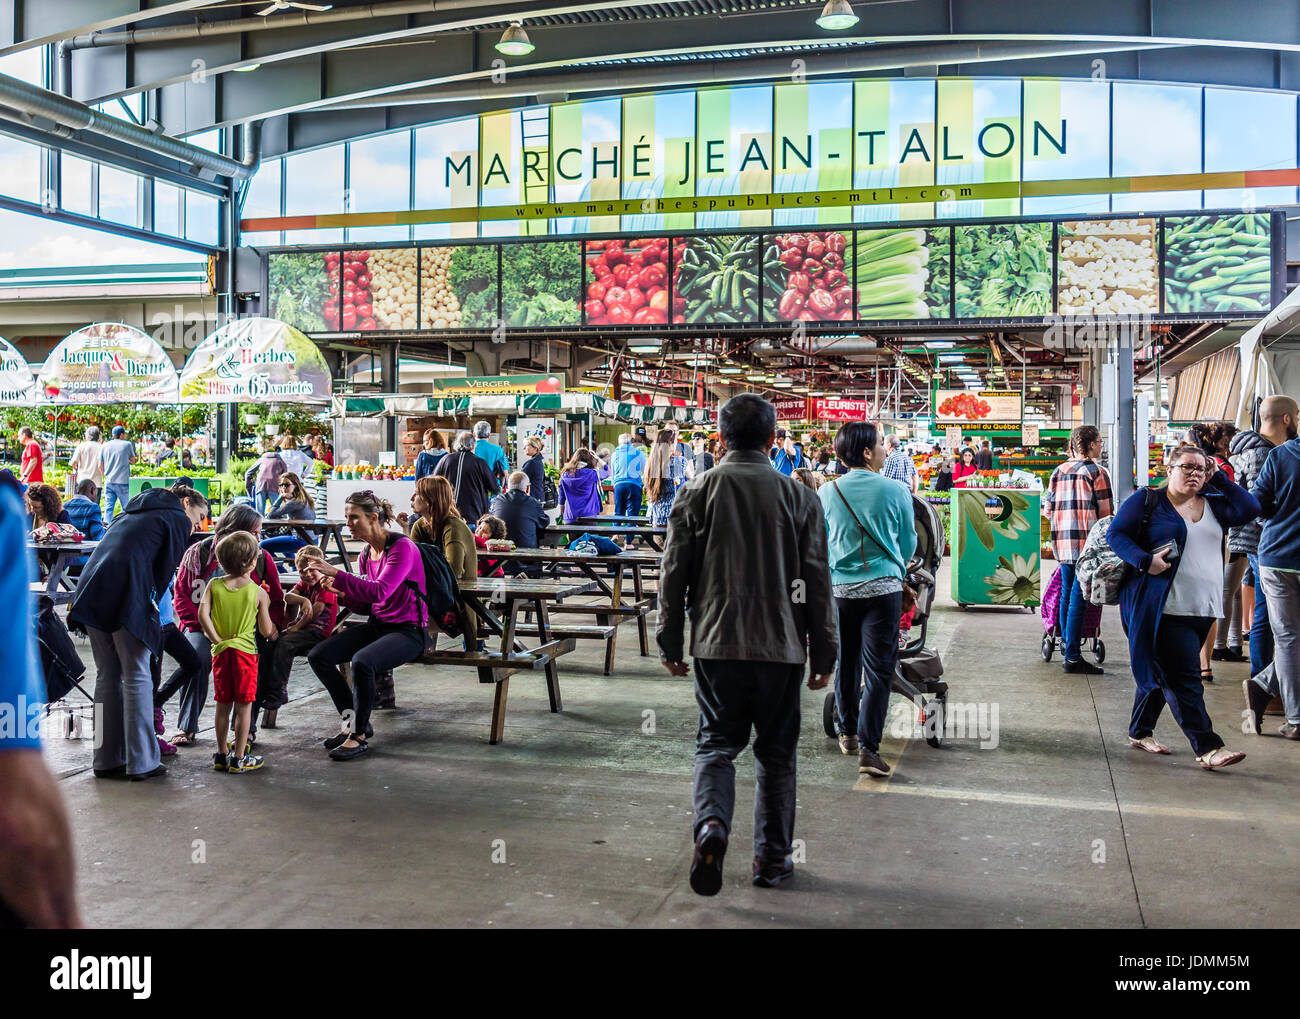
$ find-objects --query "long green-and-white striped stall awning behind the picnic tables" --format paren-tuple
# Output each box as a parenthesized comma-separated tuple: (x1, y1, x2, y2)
(332, 393, 714, 425)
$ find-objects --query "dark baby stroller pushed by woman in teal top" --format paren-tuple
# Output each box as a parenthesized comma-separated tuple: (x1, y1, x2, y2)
(822, 495, 948, 746)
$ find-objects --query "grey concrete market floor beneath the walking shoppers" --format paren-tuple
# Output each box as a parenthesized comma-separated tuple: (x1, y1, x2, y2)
(47, 565, 1300, 928)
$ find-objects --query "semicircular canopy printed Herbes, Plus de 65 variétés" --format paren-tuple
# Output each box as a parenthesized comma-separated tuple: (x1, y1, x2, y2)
(181, 318, 332, 403)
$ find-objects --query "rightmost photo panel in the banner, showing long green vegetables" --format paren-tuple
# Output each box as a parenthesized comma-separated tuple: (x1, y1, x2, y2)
(1165, 212, 1273, 315)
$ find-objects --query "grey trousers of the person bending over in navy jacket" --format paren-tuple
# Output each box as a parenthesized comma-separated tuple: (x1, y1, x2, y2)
(86, 626, 160, 775)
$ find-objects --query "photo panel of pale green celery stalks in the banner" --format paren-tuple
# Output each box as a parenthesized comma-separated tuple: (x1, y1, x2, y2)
(854, 226, 952, 321)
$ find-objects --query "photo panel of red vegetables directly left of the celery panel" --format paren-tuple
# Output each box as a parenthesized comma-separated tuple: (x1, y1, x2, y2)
(763, 230, 855, 322)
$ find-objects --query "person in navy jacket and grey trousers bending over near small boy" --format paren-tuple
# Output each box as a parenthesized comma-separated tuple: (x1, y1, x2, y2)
(68, 486, 208, 780)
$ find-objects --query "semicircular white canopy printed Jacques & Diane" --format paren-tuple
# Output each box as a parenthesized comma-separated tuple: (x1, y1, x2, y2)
(36, 322, 181, 404)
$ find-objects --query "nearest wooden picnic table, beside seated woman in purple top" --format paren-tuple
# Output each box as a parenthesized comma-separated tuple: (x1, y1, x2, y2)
(444, 577, 595, 745)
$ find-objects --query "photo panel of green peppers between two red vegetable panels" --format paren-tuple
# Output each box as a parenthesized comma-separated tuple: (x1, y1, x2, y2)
(672, 234, 759, 325)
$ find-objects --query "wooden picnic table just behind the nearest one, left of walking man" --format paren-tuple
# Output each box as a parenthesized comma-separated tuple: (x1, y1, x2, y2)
(493, 548, 663, 676)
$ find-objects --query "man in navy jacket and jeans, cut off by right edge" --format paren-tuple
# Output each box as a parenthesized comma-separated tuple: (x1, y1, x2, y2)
(1234, 396, 1300, 740)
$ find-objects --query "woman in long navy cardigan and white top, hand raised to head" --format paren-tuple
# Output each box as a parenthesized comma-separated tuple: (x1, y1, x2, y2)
(1106, 445, 1260, 769)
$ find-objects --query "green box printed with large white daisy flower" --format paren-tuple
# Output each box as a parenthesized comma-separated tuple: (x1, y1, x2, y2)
(948, 489, 1043, 608)
